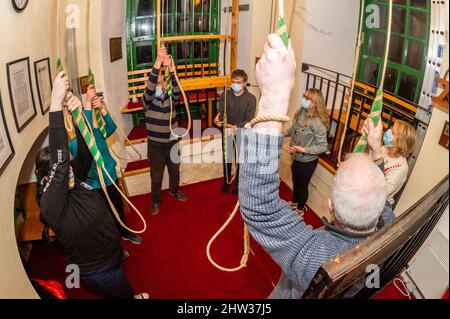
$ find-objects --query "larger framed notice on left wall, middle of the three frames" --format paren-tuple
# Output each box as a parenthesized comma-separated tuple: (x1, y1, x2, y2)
(6, 58, 36, 132)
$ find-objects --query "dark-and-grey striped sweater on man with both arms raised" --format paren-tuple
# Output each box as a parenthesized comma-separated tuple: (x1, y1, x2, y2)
(142, 68, 180, 147)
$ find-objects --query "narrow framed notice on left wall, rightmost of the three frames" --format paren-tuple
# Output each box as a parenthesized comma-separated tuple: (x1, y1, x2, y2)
(34, 58, 52, 115)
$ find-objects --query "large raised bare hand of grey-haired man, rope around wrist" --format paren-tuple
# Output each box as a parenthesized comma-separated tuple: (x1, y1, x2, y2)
(255, 34, 296, 132)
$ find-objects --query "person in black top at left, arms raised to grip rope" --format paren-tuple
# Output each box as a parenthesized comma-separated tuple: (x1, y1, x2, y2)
(36, 72, 148, 299)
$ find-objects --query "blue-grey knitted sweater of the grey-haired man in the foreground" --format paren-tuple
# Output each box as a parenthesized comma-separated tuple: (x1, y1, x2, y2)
(239, 129, 376, 299)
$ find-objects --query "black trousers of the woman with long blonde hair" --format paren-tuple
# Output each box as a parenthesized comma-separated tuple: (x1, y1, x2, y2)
(291, 159, 319, 209)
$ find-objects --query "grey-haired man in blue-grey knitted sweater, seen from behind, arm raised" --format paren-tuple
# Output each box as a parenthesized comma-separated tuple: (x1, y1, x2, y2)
(239, 34, 386, 299)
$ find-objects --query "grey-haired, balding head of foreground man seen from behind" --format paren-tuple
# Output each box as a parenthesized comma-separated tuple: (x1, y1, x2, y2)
(331, 154, 387, 231)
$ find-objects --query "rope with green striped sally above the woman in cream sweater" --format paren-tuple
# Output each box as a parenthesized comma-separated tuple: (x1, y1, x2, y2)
(354, 0, 393, 153)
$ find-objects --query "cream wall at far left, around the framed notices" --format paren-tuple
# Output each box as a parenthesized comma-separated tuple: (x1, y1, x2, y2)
(0, 1, 56, 298)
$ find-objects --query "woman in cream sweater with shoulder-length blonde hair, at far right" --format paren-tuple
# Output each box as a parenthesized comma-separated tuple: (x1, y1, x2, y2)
(363, 120, 417, 227)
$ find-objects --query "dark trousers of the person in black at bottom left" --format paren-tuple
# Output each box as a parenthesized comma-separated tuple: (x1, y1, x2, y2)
(80, 254, 134, 299)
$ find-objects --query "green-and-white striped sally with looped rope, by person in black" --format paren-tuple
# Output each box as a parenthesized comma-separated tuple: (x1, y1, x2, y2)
(56, 58, 147, 234)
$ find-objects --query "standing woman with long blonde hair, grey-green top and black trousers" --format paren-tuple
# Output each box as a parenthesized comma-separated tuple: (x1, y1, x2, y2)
(285, 89, 330, 215)
